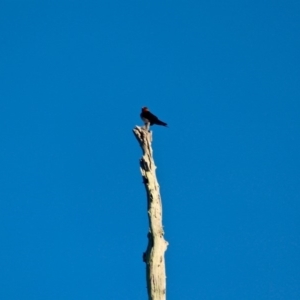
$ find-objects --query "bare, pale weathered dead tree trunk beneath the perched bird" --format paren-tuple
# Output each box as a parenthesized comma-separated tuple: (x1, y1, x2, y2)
(133, 126, 168, 300)
